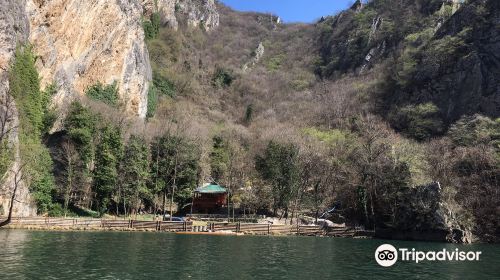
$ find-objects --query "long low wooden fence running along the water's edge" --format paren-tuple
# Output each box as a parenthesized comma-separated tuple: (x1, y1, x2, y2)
(0, 217, 323, 235)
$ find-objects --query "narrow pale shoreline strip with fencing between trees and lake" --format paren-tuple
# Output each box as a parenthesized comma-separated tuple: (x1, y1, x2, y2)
(3, 217, 373, 238)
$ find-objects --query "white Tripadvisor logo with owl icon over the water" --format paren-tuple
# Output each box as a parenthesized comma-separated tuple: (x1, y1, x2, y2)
(375, 244, 481, 267)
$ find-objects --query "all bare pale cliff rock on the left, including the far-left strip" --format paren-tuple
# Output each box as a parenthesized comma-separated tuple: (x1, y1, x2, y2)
(0, 0, 219, 215)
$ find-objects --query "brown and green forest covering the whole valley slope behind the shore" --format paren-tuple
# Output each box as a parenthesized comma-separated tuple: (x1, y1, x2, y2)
(0, 0, 500, 241)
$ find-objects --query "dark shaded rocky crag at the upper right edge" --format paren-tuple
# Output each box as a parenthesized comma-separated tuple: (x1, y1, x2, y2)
(396, 0, 500, 124)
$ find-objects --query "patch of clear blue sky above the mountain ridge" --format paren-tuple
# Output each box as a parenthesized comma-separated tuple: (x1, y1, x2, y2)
(220, 0, 355, 22)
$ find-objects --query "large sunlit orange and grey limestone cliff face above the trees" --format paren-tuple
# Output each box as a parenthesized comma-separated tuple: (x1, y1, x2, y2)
(26, 0, 151, 117)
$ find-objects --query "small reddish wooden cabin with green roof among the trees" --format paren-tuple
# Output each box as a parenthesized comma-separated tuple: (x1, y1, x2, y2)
(193, 184, 227, 214)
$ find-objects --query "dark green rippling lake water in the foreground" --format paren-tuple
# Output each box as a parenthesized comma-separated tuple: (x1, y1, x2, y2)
(0, 230, 500, 280)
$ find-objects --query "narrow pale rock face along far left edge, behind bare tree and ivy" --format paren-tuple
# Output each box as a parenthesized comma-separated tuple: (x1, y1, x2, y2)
(0, 0, 36, 216)
